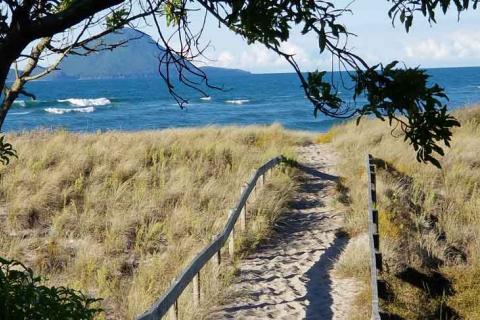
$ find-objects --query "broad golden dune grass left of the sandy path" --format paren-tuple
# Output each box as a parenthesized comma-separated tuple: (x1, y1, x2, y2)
(0, 126, 307, 319)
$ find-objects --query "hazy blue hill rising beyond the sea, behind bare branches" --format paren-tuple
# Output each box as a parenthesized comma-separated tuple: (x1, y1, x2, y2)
(7, 28, 249, 80)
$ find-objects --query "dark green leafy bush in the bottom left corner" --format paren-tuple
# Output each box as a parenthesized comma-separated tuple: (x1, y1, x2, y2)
(0, 258, 101, 320)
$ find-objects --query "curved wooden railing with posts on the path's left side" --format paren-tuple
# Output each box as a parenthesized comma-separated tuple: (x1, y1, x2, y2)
(137, 156, 285, 320)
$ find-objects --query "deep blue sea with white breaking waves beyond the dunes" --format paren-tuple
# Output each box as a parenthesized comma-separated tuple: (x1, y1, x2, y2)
(4, 67, 480, 131)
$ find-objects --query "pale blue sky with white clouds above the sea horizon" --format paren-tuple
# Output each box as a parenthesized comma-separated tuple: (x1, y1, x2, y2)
(142, 0, 480, 73)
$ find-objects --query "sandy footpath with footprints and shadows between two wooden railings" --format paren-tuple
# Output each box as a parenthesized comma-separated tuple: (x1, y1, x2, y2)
(209, 145, 356, 319)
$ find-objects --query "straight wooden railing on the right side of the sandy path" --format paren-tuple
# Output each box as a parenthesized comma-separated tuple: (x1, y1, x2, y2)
(367, 154, 383, 320)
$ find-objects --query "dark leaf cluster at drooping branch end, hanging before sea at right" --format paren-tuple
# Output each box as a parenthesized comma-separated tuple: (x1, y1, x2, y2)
(354, 61, 460, 167)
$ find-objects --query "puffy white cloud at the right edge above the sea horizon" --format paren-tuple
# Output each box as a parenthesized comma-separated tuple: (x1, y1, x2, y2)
(405, 31, 480, 65)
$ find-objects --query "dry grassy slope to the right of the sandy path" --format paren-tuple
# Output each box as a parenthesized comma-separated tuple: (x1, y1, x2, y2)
(328, 107, 480, 319)
